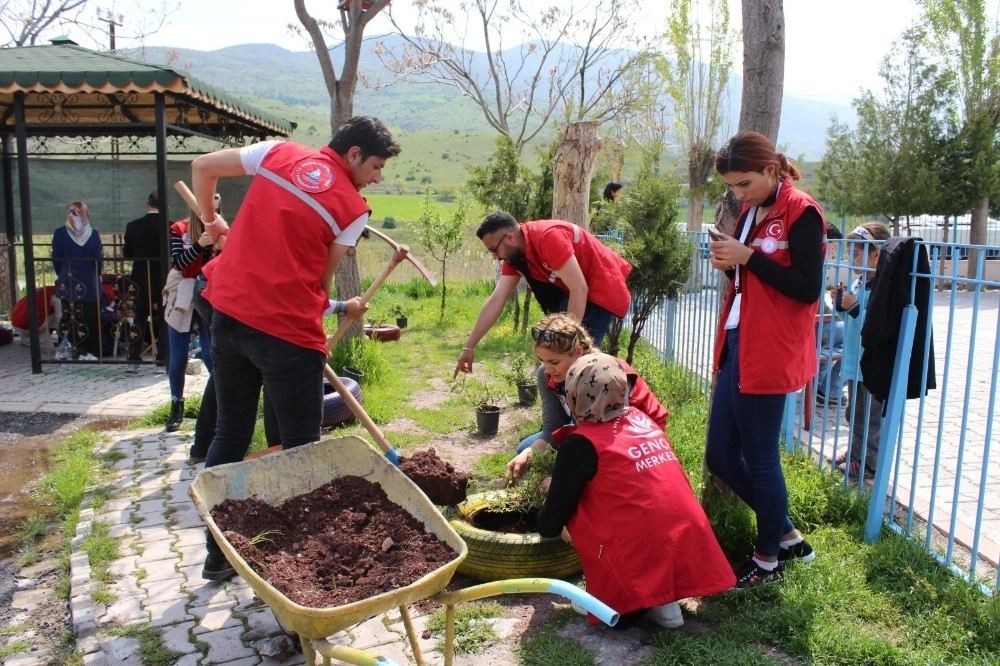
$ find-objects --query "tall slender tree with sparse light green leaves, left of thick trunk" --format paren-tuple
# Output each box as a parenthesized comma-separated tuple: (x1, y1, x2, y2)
(659, 0, 736, 231)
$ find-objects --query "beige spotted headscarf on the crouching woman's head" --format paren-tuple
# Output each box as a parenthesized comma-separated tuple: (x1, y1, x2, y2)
(566, 354, 628, 423)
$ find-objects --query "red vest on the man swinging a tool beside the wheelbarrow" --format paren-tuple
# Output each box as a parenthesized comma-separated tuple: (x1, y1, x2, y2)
(204, 142, 371, 353)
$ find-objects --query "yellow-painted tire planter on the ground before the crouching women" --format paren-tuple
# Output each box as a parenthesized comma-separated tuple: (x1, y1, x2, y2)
(445, 491, 580, 582)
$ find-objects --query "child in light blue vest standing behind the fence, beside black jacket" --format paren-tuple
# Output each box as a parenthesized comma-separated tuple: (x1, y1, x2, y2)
(830, 222, 889, 478)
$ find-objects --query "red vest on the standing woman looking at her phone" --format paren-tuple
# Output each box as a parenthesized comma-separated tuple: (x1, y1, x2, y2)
(713, 179, 823, 394)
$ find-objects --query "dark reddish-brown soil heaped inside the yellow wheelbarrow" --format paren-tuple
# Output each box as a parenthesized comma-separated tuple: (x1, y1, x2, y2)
(212, 476, 458, 608)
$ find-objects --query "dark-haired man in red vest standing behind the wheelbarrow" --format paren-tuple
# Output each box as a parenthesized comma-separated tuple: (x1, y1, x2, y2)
(191, 116, 400, 580)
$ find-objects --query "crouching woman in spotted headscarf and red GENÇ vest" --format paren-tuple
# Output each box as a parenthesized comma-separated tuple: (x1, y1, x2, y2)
(538, 354, 736, 628)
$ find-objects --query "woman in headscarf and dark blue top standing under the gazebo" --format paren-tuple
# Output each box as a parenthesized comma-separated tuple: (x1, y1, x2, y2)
(52, 201, 104, 361)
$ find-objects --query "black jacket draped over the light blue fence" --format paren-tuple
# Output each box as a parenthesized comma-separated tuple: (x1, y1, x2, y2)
(861, 236, 937, 404)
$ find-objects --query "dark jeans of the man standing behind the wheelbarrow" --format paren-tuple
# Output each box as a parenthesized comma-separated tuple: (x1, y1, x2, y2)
(205, 311, 326, 468)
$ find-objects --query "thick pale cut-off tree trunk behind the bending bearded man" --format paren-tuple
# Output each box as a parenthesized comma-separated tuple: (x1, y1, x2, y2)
(552, 120, 601, 229)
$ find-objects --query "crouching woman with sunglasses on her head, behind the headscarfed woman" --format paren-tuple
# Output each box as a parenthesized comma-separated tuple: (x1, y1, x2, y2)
(508, 313, 667, 470)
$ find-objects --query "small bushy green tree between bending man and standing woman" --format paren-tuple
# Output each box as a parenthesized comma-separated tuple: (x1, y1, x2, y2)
(609, 160, 693, 363)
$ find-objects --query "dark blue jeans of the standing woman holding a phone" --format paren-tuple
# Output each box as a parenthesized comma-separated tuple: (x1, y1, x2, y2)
(705, 329, 795, 557)
